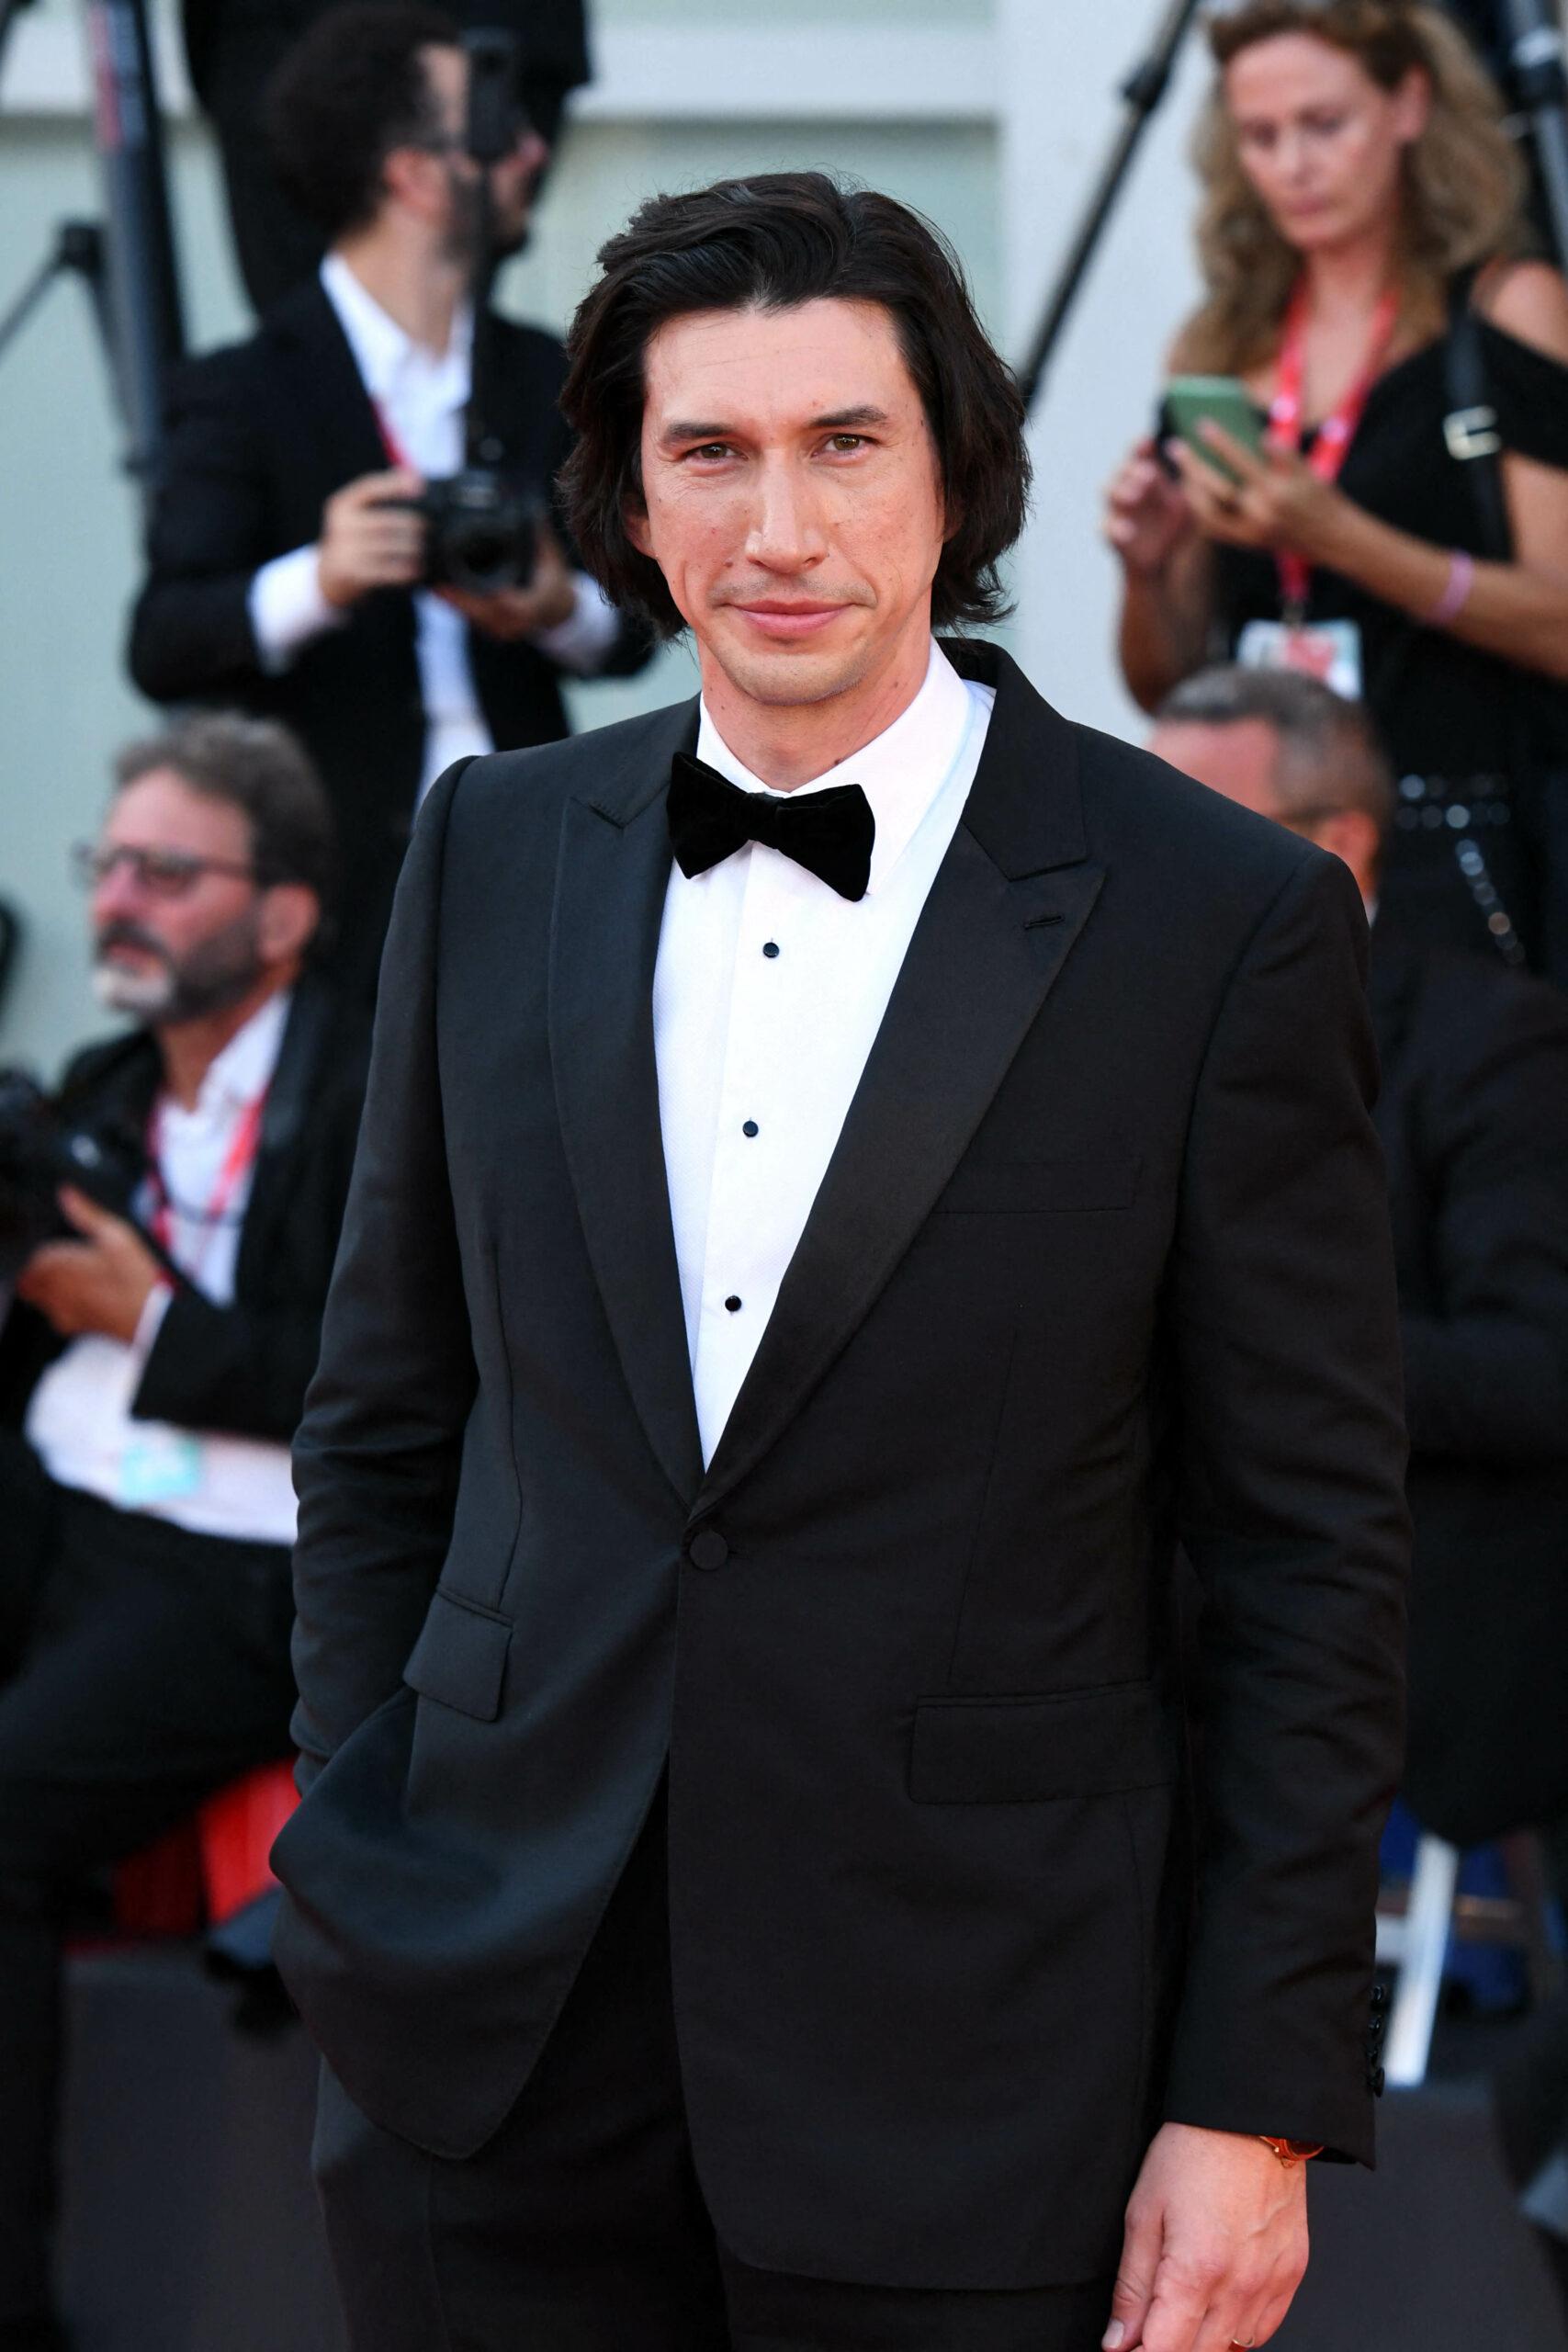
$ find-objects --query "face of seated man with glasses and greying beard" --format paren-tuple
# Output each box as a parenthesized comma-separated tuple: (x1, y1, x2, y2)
(92, 767, 265, 1023)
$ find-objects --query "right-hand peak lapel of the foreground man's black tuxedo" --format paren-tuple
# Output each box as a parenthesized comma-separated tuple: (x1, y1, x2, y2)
(696, 656, 1105, 1510)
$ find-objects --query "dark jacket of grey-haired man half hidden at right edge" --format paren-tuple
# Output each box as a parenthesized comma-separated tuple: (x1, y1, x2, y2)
(1371, 922, 1568, 1847)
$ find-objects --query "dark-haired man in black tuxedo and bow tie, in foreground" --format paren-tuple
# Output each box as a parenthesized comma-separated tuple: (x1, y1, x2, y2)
(277, 174, 1405, 2352)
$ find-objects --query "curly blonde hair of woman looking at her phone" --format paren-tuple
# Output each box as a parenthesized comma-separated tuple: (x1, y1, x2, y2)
(1176, 0, 1528, 374)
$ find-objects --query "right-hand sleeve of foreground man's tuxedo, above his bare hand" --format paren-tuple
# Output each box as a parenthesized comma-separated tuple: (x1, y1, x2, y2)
(1166, 854, 1408, 2162)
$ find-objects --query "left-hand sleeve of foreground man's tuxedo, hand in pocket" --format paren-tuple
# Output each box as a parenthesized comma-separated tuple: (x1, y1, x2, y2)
(294, 760, 478, 1790)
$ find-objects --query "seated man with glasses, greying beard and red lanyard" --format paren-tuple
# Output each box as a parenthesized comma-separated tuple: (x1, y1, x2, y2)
(0, 718, 365, 2352)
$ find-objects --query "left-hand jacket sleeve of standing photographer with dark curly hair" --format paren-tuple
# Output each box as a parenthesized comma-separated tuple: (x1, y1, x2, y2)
(127, 353, 280, 703)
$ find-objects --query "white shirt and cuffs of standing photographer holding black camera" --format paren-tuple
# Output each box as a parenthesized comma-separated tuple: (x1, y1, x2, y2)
(249, 254, 618, 797)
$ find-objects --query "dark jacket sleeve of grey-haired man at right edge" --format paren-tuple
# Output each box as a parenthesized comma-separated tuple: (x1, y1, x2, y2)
(1404, 983, 1568, 1470)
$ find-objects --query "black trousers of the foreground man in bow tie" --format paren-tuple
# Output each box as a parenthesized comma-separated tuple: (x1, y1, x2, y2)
(315, 1806, 1112, 2352)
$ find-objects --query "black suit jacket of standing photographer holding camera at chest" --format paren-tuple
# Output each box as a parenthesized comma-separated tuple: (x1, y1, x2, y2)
(130, 280, 649, 992)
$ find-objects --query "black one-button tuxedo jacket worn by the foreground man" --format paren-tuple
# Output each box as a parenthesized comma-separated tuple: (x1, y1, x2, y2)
(277, 647, 1408, 2289)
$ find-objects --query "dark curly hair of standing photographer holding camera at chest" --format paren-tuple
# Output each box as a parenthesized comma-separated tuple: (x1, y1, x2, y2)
(261, 0, 461, 244)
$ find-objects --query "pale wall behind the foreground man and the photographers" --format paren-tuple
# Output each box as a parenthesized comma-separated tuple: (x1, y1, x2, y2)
(0, 0, 1201, 1066)
